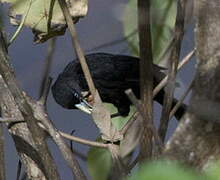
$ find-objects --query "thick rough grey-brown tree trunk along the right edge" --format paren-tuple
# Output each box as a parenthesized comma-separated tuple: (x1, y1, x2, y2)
(164, 0, 220, 169)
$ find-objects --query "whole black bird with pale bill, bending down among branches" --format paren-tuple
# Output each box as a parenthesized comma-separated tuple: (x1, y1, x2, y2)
(52, 53, 186, 118)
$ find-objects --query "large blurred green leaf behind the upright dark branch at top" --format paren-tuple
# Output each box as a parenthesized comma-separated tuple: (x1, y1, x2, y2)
(123, 0, 177, 63)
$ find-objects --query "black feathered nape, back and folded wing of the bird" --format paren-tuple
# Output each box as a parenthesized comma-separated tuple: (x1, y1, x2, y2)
(59, 53, 139, 90)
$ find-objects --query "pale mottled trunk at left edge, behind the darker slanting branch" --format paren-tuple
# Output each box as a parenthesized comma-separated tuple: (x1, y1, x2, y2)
(0, 76, 46, 180)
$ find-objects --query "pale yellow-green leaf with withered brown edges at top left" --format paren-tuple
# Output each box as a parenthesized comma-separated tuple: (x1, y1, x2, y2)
(0, 0, 88, 42)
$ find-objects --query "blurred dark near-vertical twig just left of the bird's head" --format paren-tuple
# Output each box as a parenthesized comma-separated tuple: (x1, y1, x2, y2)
(39, 38, 56, 104)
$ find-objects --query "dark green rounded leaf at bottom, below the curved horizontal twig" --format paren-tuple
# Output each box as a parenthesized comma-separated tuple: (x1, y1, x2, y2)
(87, 143, 112, 180)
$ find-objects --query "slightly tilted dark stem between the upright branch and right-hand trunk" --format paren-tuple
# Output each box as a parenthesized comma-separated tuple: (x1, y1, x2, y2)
(158, 1, 185, 141)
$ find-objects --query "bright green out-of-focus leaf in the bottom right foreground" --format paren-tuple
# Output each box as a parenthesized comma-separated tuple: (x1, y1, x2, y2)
(128, 161, 207, 180)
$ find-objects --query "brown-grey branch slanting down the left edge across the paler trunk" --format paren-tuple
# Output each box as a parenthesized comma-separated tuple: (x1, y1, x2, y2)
(0, 33, 59, 180)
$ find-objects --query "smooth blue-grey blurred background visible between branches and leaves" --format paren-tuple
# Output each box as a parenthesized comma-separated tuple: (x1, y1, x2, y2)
(1, 0, 195, 180)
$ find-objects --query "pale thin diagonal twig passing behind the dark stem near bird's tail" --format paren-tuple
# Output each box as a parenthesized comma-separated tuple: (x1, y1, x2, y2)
(153, 49, 195, 97)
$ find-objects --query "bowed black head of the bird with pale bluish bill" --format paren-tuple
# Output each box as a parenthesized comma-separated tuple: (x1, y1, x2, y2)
(52, 78, 92, 114)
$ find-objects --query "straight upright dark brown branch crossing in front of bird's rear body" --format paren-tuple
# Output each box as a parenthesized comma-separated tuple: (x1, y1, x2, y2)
(138, 0, 153, 160)
